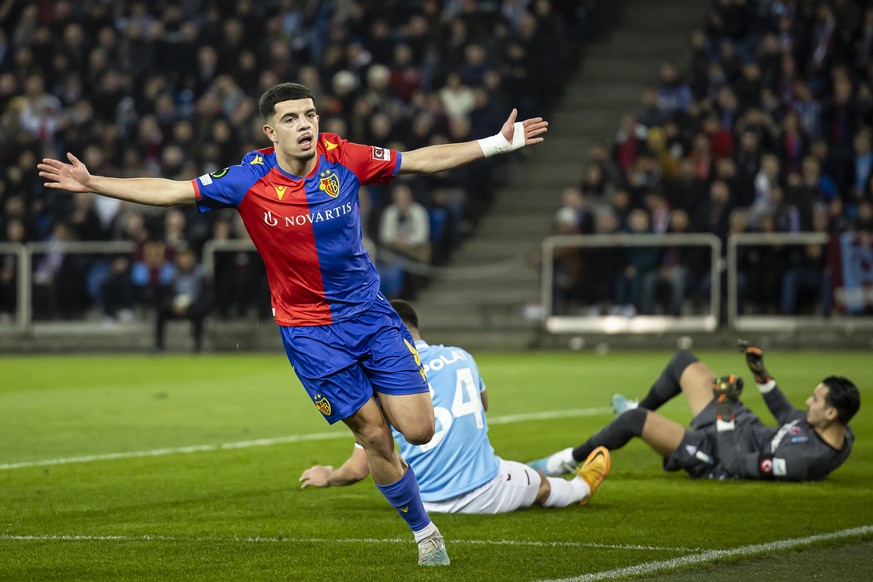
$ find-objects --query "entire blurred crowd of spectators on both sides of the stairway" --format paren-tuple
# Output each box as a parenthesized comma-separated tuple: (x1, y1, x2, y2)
(0, 0, 873, 338)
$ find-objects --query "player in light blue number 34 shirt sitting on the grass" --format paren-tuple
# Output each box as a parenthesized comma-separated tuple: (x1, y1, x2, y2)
(300, 300, 610, 514)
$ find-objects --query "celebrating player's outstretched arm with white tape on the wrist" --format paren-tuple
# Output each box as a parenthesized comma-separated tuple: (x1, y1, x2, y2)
(400, 109, 549, 174)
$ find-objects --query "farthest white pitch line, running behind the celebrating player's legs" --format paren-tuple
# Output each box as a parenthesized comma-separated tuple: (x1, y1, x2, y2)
(0, 408, 612, 471)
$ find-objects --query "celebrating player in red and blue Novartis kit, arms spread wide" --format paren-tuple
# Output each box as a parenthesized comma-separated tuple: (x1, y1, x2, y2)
(38, 83, 548, 565)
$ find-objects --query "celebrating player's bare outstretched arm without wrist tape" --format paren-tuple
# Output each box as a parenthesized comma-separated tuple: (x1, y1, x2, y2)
(37, 153, 197, 206)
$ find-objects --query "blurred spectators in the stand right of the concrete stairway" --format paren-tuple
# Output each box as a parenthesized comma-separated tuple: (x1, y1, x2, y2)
(554, 0, 873, 315)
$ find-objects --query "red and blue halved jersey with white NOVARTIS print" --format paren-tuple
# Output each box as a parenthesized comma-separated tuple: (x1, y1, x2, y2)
(193, 133, 401, 326)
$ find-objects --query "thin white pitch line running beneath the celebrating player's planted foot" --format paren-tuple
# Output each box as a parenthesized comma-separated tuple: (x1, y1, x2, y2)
(0, 534, 700, 552)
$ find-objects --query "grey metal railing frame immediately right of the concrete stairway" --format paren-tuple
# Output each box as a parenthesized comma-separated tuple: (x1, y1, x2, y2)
(542, 234, 722, 334)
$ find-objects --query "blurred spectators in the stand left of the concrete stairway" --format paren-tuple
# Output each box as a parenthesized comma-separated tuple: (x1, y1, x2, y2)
(0, 0, 612, 320)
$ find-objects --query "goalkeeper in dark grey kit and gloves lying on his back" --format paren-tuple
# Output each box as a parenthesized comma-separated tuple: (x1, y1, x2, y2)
(529, 341, 861, 481)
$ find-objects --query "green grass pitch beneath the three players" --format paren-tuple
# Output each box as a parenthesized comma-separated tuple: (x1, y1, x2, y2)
(0, 352, 873, 581)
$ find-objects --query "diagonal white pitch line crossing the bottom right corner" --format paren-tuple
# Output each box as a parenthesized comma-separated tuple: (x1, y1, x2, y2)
(545, 525, 873, 582)
